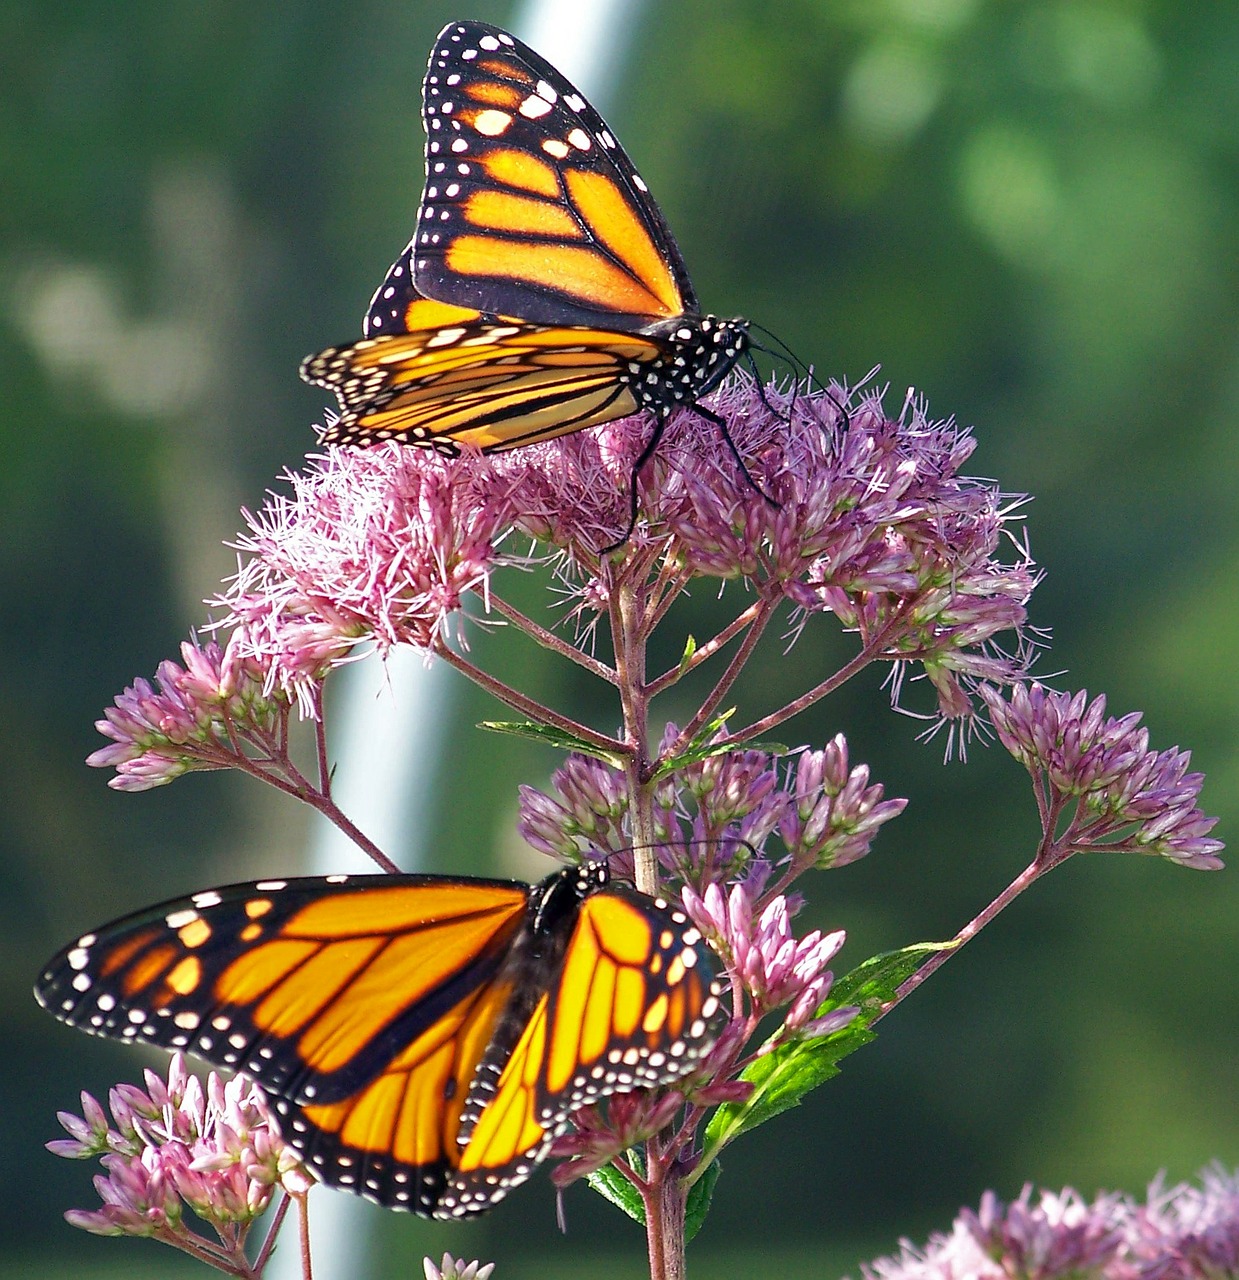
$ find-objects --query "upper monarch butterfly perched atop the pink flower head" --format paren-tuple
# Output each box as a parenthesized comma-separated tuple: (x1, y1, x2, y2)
(301, 22, 749, 504)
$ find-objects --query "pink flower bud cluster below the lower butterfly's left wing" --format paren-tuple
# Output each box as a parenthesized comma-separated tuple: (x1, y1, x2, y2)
(47, 1053, 312, 1252)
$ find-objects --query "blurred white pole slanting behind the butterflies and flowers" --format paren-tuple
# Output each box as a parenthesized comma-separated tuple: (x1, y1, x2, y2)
(266, 0, 644, 1280)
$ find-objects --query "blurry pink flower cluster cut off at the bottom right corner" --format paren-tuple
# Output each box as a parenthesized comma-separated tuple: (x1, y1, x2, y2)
(861, 1166, 1239, 1280)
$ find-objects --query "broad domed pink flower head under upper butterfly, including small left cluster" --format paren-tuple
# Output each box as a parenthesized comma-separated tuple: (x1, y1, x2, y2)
(93, 376, 1037, 787)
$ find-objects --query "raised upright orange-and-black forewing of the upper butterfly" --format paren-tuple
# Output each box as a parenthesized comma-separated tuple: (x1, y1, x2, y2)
(411, 22, 698, 332)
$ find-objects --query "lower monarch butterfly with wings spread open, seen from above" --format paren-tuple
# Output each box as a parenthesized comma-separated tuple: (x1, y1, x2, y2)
(35, 863, 724, 1219)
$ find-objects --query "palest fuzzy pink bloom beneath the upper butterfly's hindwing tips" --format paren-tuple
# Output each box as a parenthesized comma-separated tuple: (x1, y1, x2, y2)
(215, 444, 515, 696)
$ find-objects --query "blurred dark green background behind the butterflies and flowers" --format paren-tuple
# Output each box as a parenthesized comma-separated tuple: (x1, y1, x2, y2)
(0, 0, 1239, 1280)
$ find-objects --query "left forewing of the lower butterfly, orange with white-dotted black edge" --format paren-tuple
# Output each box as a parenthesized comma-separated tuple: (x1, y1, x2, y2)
(36, 876, 527, 1100)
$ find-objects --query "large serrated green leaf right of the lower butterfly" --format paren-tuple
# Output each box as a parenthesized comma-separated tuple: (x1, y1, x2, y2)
(705, 942, 959, 1160)
